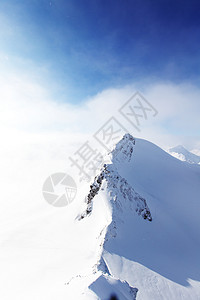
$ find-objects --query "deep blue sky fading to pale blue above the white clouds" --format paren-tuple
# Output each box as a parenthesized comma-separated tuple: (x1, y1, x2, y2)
(0, 0, 200, 103)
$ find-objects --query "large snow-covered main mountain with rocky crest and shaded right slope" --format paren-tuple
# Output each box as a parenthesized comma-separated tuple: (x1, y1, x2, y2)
(79, 134, 200, 300)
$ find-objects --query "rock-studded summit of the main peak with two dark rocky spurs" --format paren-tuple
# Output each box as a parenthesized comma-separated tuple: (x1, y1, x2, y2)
(79, 134, 152, 225)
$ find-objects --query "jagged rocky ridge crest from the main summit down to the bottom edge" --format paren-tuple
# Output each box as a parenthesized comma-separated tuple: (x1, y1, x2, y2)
(78, 134, 152, 300)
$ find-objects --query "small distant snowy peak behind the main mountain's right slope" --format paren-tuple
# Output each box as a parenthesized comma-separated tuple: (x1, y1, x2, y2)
(169, 145, 200, 164)
